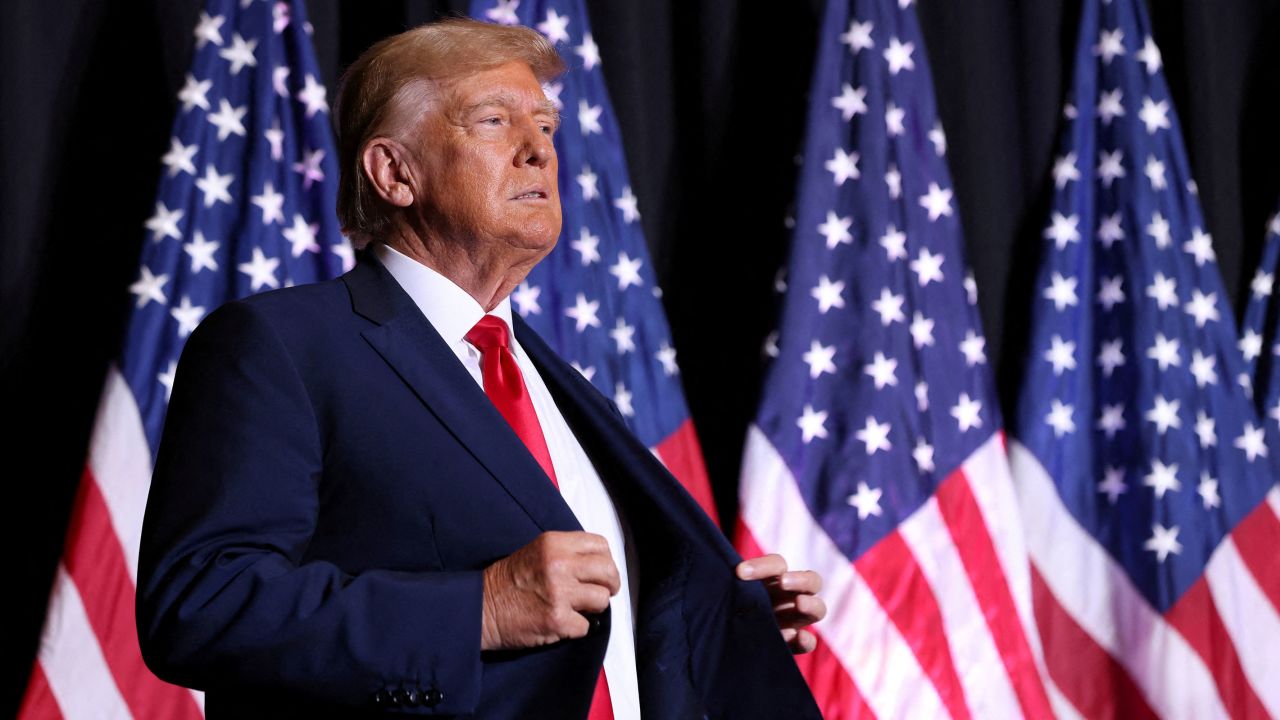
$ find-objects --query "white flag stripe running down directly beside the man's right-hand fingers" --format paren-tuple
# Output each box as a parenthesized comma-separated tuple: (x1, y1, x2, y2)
(741, 424, 946, 717)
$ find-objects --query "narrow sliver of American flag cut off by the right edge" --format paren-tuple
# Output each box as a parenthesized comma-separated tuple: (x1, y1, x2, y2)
(1238, 210, 1280, 425)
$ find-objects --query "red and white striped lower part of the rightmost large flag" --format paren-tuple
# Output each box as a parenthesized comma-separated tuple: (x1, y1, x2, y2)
(1010, 443, 1280, 719)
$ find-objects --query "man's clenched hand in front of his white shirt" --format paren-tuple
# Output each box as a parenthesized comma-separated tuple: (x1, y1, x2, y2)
(480, 532, 621, 650)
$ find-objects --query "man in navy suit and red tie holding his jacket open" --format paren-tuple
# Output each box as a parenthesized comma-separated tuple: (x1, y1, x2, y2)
(138, 19, 826, 720)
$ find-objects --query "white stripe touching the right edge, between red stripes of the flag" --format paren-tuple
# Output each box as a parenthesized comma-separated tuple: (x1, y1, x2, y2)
(1204, 535, 1280, 717)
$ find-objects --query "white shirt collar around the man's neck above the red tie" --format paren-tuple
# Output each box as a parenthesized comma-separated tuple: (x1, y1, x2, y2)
(374, 242, 516, 347)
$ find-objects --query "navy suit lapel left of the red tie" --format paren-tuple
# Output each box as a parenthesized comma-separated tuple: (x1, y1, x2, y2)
(342, 251, 581, 530)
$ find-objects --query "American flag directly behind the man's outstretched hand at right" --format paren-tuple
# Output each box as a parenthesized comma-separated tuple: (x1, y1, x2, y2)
(737, 0, 1051, 719)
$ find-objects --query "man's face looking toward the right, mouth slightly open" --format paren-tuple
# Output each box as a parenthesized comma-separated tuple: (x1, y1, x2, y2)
(412, 61, 561, 258)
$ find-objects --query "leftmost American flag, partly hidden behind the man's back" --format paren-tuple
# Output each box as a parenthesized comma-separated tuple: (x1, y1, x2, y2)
(19, 0, 352, 720)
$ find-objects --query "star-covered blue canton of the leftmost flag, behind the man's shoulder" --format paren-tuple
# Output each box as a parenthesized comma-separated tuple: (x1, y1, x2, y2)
(120, 0, 353, 456)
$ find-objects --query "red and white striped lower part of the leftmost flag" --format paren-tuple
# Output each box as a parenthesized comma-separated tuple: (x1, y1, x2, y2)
(18, 366, 204, 720)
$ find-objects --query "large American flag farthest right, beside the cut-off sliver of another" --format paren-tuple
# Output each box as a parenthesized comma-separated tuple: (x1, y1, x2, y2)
(1011, 0, 1280, 717)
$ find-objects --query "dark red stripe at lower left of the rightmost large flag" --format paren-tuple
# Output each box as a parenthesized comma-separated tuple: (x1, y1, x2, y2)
(1032, 566, 1157, 720)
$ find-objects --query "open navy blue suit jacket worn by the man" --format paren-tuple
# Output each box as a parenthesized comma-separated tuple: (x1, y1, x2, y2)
(137, 244, 819, 720)
